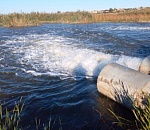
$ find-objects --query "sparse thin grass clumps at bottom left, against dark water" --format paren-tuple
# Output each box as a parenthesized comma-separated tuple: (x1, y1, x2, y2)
(0, 98, 62, 130)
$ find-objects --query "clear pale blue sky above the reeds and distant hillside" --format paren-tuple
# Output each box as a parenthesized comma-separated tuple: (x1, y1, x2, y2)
(0, 0, 150, 14)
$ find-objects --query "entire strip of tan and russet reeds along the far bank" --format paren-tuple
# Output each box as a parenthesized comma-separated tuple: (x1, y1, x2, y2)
(0, 8, 150, 27)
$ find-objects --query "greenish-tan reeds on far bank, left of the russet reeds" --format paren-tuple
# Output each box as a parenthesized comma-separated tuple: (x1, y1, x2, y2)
(0, 11, 92, 27)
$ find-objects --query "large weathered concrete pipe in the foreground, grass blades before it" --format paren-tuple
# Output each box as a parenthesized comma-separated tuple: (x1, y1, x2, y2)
(97, 63, 150, 109)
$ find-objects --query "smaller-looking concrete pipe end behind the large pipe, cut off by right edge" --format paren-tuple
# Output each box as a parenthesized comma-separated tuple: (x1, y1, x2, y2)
(139, 56, 150, 75)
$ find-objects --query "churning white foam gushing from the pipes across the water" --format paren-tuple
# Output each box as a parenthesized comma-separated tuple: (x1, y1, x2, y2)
(4, 34, 142, 77)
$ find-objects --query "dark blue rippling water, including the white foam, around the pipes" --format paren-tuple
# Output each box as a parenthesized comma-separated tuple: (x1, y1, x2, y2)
(0, 23, 150, 130)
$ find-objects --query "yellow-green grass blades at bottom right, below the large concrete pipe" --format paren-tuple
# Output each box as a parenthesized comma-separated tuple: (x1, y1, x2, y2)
(109, 96, 150, 130)
